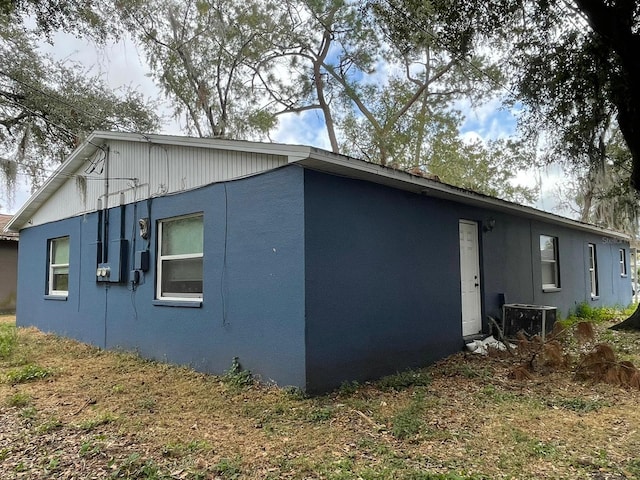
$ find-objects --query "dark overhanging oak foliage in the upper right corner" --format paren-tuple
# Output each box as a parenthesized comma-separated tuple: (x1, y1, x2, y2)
(374, 0, 640, 199)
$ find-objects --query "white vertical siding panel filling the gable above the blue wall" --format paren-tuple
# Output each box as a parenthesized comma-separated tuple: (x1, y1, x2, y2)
(25, 141, 287, 225)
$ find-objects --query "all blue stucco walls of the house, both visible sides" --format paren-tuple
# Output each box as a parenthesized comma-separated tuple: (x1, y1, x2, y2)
(12, 165, 631, 392)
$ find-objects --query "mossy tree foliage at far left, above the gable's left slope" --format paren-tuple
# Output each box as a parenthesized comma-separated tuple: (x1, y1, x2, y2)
(0, 18, 159, 200)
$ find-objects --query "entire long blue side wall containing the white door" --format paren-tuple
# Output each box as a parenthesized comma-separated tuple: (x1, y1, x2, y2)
(305, 171, 631, 392)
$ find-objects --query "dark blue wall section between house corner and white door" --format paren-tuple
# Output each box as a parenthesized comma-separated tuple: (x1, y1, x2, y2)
(305, 171, 463, 391)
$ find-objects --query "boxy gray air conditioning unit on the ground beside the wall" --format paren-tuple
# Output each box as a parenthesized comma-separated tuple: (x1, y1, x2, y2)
(502, 303, 557, 341)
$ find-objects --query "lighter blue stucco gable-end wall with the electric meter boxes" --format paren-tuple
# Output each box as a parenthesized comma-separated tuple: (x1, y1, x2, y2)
(17, 167, 306, 385)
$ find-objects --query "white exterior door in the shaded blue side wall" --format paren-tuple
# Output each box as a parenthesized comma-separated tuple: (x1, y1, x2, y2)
(460, 220, 482, 336)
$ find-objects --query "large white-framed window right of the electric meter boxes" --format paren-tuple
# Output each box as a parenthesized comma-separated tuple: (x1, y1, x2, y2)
(156, 214, 204, 300)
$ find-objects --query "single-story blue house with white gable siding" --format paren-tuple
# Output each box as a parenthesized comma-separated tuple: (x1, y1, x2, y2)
(9, 132, 631, 392)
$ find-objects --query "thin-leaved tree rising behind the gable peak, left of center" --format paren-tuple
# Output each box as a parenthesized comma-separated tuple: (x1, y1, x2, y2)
(117, 0, 280, 139)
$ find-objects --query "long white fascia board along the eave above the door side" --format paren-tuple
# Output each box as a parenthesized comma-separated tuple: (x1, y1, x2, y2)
(297, 149, 631, 242)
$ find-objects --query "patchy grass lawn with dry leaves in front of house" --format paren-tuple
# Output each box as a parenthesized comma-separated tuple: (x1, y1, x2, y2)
(0, 312, 640, 480)
